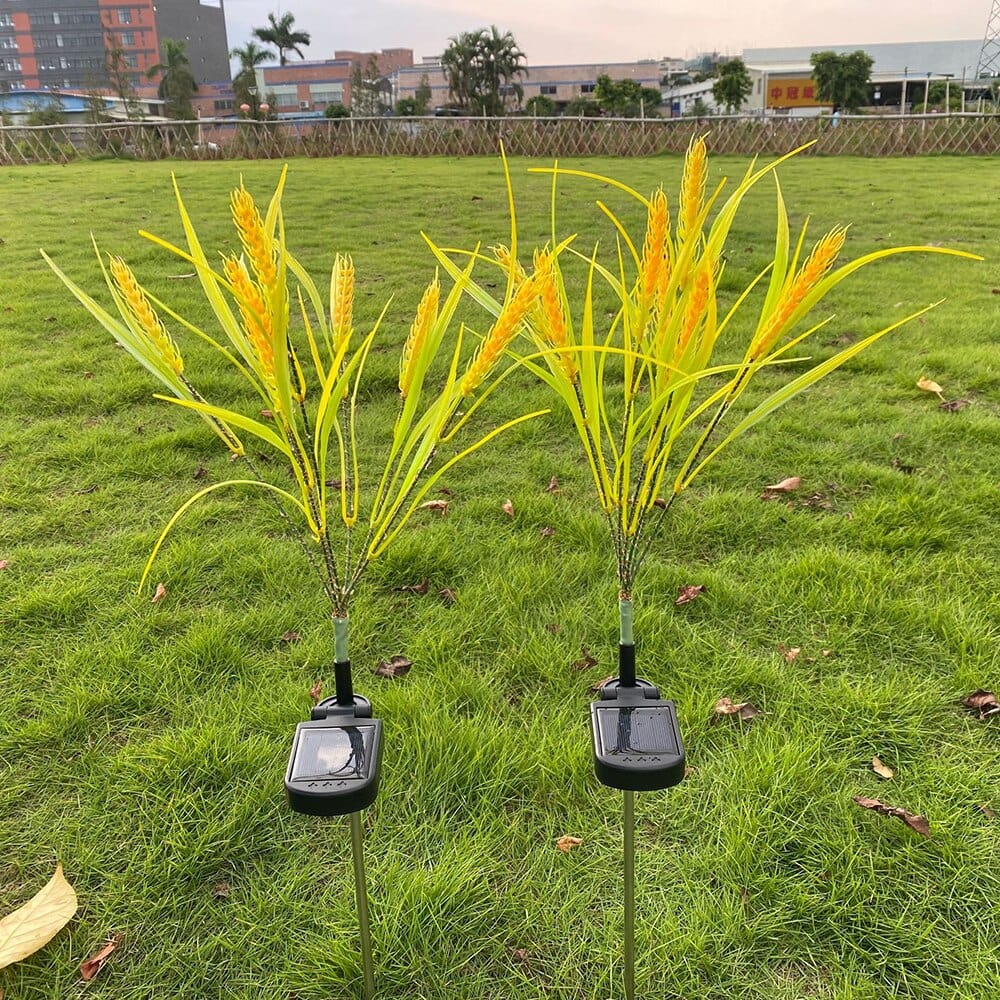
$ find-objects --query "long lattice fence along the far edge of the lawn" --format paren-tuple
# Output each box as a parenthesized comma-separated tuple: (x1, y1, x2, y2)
(0, 114, 1000, 166)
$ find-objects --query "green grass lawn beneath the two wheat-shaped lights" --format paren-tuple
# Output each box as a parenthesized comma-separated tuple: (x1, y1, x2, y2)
(0, 150, 1000, 1000)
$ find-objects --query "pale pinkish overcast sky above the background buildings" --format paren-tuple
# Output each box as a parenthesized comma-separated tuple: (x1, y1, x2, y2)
(225, 0, 992, 66)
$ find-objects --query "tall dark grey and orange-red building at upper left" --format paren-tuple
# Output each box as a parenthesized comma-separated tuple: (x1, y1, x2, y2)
(0, 0, 230, 92)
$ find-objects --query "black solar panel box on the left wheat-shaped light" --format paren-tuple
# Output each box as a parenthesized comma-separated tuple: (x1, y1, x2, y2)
(285, 695, 382, 816)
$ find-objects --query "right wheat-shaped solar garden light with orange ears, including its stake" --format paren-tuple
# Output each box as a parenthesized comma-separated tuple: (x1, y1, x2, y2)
(431, 138, 973, 1000)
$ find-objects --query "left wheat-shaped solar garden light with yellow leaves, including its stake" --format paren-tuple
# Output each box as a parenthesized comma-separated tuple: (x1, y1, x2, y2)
(45, 171, 547, 997)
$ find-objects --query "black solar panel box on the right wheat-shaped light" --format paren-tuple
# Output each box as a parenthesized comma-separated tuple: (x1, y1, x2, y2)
(590, 679, 684, 792)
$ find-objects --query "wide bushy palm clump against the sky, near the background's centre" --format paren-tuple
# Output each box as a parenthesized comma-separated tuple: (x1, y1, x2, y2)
(441, 24, 527, 116)
